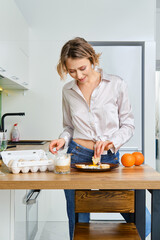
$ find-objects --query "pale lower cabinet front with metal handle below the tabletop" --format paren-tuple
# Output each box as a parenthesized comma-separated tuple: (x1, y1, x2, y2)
(14, 190, 41, 240)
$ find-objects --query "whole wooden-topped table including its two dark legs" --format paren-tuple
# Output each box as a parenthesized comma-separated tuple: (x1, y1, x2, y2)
(0, 165, 160, 240)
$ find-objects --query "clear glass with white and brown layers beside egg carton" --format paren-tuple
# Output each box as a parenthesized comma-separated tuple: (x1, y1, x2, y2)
(54, 153, 71, 174)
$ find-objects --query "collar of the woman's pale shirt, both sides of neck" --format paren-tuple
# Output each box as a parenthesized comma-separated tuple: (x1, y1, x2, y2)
(65, 68, 112, 89)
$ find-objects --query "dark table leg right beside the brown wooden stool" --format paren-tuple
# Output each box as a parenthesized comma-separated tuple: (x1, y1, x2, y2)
(135, 190, 146, 240)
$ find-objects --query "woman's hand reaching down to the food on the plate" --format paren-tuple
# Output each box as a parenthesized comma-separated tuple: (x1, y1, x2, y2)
(94, 140, 114, 158)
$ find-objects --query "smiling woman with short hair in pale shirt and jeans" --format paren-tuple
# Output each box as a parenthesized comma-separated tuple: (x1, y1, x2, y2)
(50, 37, 150, 240)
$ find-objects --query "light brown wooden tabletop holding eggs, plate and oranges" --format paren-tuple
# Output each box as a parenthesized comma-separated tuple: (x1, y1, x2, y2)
(0, 165, 160, 189)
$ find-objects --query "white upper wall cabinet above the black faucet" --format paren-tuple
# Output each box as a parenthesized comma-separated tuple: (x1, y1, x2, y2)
(0, 0, 29, 89)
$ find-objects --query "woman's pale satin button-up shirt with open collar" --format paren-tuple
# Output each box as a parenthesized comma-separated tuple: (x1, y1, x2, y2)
(59, 69, 134, 152)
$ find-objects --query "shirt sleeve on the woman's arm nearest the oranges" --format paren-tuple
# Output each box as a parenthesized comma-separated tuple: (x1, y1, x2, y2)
(109, 80, 135, 152)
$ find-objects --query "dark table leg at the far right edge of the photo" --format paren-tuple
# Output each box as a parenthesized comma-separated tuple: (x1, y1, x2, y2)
(151, 190, 160, 240)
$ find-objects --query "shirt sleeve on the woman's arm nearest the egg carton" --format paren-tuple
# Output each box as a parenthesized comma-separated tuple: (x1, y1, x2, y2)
(59, 90, 73, 148)
